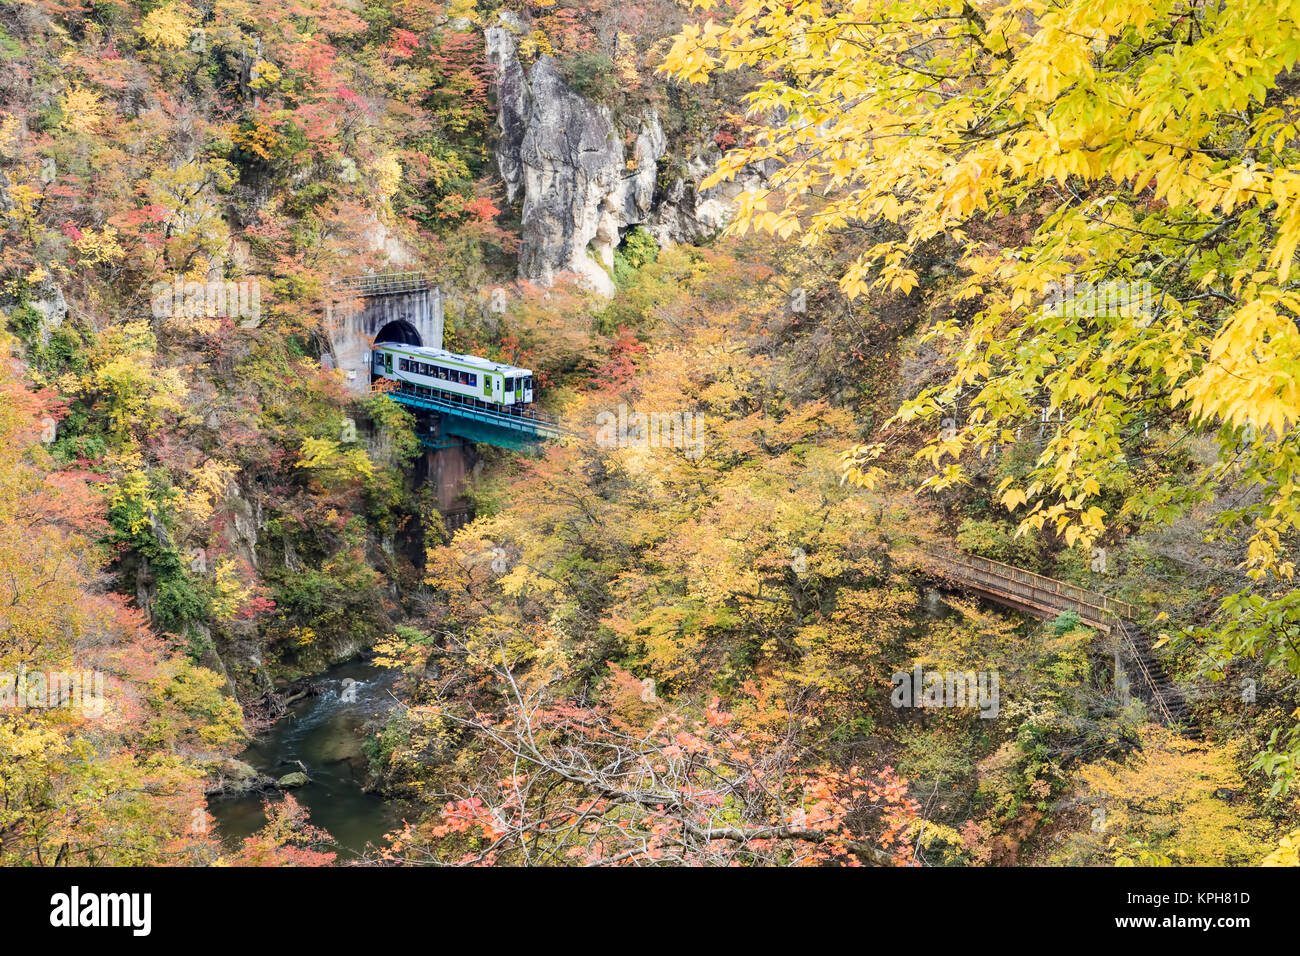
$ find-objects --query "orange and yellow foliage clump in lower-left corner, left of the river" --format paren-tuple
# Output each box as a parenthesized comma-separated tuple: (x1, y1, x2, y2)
(0, 342, 243, 865)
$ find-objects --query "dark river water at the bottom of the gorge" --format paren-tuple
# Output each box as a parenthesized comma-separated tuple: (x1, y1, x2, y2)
(208, 661, 406, 862)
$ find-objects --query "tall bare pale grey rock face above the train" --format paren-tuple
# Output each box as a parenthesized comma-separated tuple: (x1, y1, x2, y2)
(485, 26, 667, 295)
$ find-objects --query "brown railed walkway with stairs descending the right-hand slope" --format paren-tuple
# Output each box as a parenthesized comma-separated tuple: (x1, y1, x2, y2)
(917, 546, 1195, 730)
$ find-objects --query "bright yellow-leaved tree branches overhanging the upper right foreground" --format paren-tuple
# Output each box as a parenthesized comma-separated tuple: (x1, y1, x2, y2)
(663, 0, 1300, 788)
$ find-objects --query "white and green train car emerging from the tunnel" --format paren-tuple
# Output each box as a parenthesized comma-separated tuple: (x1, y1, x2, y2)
(371, 342, 533, 411)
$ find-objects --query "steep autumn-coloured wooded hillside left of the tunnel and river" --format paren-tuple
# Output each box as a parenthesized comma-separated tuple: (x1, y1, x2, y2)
(0, 0, 501, 864)
